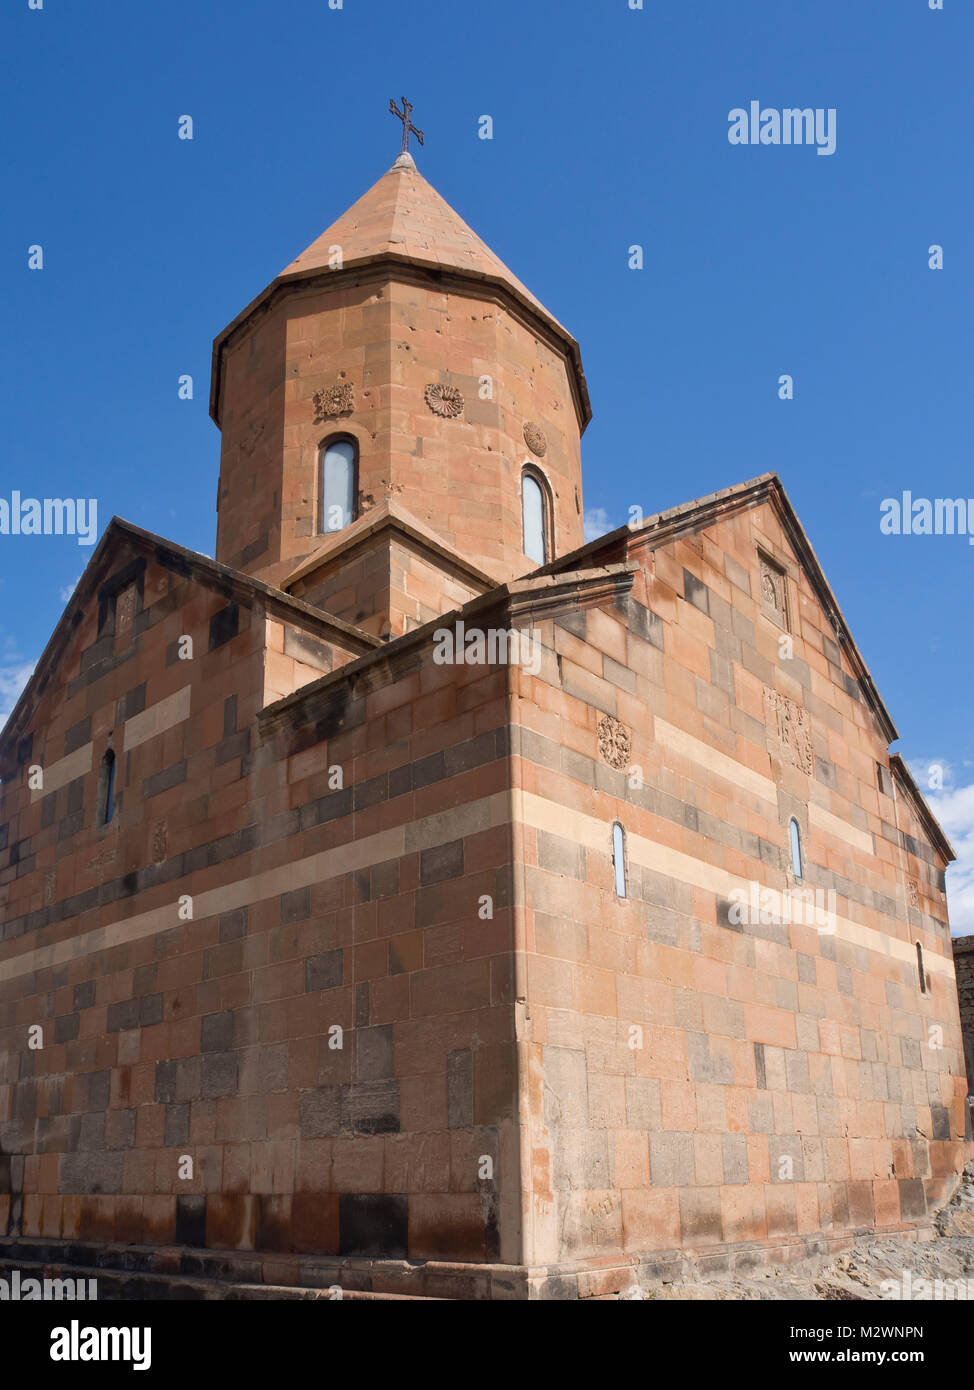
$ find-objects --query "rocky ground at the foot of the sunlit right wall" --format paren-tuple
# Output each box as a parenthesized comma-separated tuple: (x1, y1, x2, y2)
(622, 1163, 974, 1300)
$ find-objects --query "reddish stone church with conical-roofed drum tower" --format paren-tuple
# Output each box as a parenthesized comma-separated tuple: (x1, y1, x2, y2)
(0, 146, 971, 1298)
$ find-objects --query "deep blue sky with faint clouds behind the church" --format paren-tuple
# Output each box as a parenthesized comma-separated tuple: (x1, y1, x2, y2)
(0, 0, 974, 933)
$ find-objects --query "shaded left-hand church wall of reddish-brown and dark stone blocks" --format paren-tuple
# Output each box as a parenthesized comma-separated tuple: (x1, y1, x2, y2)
(0, 542, 518, 1277)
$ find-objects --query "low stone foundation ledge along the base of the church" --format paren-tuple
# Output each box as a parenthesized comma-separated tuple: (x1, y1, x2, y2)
(0, 1226, 931, 1301)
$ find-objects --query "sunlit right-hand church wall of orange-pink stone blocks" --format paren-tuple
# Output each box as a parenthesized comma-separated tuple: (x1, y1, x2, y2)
(514, 505, 964, 1264)
